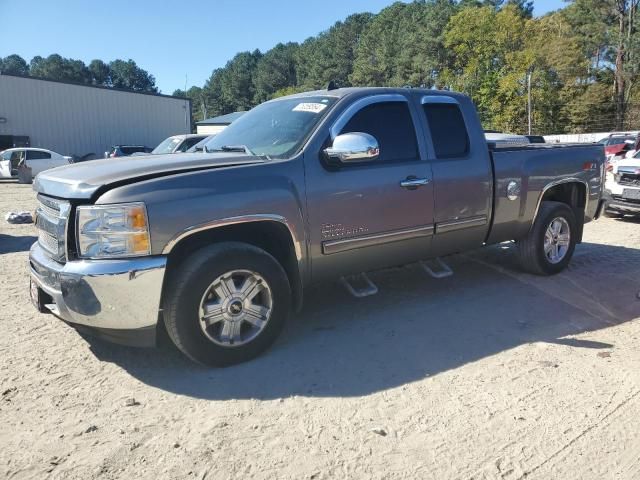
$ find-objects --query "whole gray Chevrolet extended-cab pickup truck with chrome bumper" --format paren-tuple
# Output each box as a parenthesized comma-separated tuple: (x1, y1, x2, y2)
(29, 88, 605, 365)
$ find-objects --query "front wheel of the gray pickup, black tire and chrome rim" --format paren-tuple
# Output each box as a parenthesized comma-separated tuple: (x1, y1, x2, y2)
(163, 242, 291, 366)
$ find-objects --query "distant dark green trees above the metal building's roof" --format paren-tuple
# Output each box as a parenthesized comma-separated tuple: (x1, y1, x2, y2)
(0, 54, 158, 93)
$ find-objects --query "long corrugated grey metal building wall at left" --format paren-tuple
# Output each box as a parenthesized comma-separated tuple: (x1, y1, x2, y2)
(0, 75, 191, 158)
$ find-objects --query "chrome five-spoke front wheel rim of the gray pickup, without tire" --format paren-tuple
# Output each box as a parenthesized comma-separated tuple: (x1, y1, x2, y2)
(199, 270, 273, 347)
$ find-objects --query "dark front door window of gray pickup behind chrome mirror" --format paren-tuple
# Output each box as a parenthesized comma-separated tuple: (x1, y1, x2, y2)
(340, 102, 419, 162)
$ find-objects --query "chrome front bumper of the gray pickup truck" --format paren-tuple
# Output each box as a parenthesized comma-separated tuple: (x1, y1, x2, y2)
(29, 242, 167, 346)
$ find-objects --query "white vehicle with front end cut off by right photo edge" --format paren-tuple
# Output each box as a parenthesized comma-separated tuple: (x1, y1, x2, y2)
(604, 153, 640, 218)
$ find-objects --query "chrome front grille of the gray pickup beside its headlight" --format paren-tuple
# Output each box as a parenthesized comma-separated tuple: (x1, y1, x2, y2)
(36, 195, 71, 262)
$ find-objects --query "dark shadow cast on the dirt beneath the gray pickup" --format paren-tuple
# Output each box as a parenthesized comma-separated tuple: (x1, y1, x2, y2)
(91, 243, 640, 400)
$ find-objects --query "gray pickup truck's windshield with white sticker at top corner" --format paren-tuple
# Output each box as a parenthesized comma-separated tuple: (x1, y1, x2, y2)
(205, 96, 337, 158)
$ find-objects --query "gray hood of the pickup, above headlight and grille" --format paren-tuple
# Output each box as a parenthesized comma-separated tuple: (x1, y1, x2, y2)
(33, 152, 264, 199)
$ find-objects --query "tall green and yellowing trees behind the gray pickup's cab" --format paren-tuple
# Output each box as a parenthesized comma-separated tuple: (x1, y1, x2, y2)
(174, 0, 640, 134)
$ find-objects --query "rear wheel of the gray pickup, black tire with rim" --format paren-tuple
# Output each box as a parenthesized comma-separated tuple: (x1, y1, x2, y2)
(518, 202, 578, 275)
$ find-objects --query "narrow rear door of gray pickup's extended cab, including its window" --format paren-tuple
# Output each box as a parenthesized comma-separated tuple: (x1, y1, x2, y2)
(420, 95, 493, 256)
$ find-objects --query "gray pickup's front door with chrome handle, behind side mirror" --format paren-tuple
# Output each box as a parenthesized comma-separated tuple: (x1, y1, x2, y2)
(305, 94, 433, 280)
